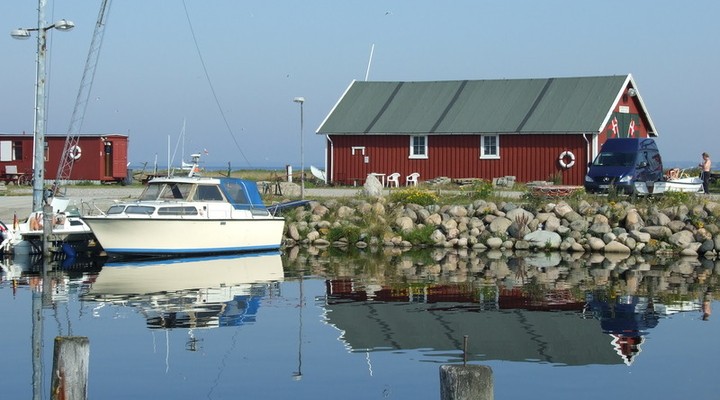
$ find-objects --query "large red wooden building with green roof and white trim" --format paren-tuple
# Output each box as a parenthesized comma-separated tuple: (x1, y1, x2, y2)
(317, 75, 657, 185)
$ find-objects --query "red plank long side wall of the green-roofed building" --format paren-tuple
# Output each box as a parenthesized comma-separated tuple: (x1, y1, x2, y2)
(328, 134, 592, 185)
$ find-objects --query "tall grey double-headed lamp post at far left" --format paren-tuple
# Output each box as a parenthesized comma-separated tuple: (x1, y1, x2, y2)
(10, 0, 75, 211)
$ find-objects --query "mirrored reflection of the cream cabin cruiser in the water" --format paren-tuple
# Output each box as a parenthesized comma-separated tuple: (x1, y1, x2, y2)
(83, 252, 283, 328)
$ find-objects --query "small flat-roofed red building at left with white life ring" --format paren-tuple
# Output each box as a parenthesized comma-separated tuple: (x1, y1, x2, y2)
(0, 133, 128, 182)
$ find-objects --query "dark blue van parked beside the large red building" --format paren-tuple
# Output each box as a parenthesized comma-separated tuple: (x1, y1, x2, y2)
(585, 138, 663, 194)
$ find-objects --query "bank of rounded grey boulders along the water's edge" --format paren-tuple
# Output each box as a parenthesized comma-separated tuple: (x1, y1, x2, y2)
(285, 197, 720, 259)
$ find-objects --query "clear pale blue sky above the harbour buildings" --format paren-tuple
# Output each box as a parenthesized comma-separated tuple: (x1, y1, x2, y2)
(0, 0, 720, 169)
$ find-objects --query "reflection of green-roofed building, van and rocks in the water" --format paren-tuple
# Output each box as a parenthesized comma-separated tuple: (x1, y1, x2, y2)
(289, 250, 717, 365)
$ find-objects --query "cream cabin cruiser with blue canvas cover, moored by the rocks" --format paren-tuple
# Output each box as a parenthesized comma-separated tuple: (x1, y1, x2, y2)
(83, 154, 285, 256)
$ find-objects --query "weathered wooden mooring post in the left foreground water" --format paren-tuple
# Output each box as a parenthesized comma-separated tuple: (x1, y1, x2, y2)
(50, 336, 90, 400)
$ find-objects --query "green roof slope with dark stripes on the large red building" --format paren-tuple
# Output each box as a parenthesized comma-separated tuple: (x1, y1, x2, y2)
(317, 75, 632, 135)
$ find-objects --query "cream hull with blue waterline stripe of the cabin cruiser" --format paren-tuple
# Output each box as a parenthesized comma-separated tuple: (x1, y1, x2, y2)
(84, 217, 285, 256)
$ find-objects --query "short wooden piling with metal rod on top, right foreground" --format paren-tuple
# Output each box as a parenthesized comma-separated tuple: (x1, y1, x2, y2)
(440, 365, 494, 400)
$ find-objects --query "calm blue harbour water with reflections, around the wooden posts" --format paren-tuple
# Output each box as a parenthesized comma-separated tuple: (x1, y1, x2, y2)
(0, 249, 720, 400)
